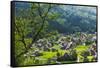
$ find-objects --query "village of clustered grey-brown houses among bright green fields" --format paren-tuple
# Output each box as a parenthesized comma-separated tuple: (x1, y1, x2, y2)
(24, 32, 97, 65)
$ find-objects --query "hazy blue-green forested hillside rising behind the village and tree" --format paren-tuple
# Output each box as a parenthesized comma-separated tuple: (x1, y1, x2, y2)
(16, 3, 96, 34)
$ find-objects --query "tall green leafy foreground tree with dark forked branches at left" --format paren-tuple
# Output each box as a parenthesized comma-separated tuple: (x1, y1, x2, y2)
(15, 3, 59, 64)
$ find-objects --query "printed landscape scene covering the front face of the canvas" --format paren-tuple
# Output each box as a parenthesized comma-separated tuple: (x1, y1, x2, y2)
(14, 2, 97, 66)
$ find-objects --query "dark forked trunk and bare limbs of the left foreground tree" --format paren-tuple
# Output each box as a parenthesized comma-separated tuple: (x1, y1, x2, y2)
(16, 4, 54, 58)
